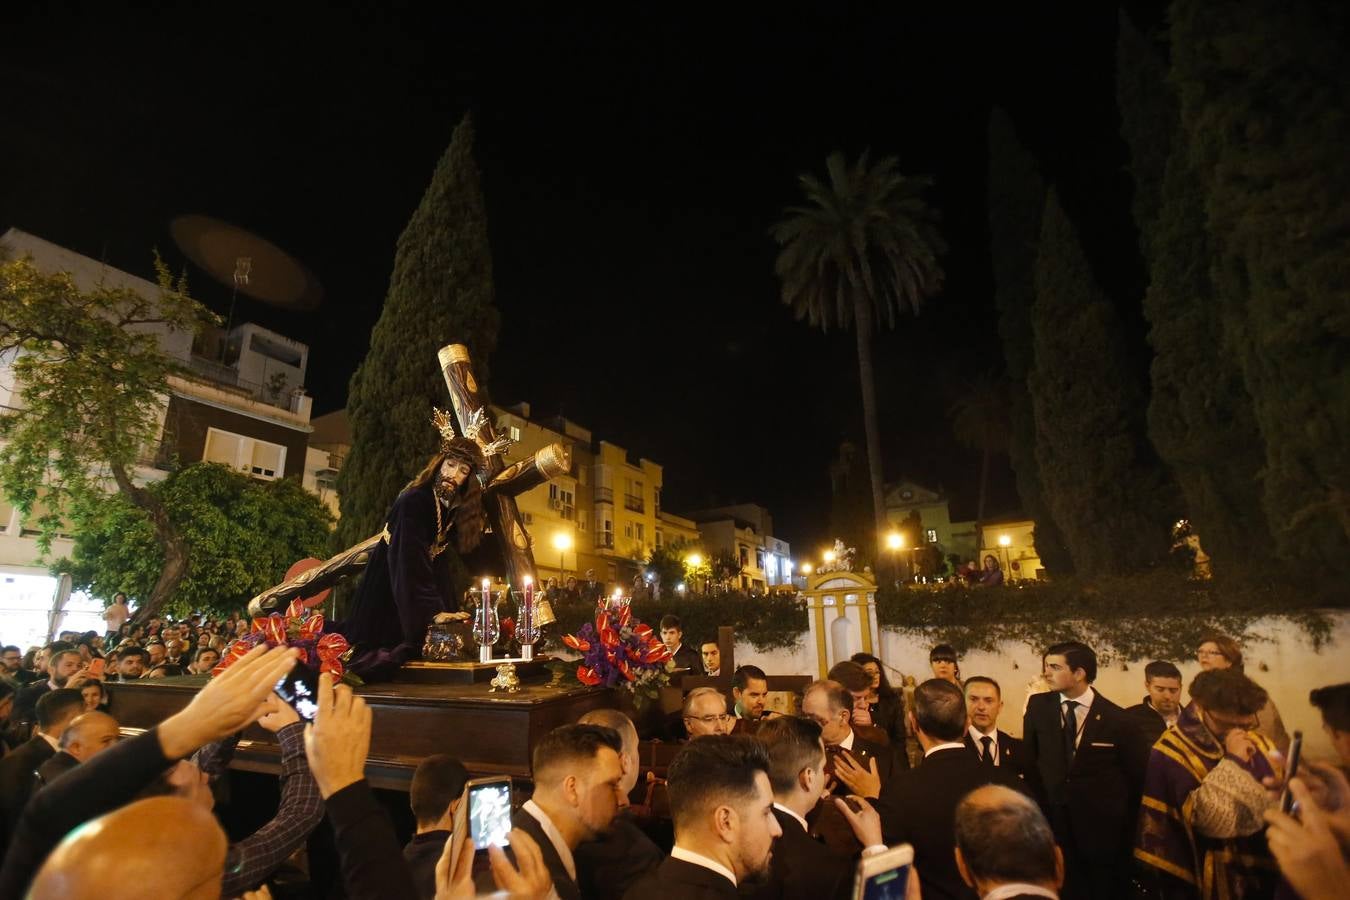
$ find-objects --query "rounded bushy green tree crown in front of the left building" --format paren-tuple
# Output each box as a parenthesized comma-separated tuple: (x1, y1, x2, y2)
(51, 463, 332, 615)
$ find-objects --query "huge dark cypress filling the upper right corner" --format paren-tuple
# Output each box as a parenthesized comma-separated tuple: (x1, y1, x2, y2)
(1170, 0, 1350, 572)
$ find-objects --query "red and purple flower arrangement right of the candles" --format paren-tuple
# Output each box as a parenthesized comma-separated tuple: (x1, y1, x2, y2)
(563, 599, 671, 704)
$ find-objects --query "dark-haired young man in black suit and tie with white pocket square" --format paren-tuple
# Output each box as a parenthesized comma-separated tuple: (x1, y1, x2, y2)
(1022, 641, 1149, 900)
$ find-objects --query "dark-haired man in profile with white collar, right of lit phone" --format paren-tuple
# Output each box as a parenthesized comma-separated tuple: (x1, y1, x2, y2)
(512, 725, 624, 900)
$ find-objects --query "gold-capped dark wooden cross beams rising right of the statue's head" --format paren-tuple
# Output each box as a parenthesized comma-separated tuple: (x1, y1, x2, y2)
(436, 344, 572, 588)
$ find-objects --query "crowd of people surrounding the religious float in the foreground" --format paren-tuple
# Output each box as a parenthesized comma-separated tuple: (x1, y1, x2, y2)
(0, 617, 1350, 900)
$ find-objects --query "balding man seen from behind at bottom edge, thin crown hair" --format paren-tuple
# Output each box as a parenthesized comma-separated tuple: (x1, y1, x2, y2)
(956, 784, 1064, 900)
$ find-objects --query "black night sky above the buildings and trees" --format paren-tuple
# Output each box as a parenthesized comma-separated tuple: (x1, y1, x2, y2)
(0, 4, 1141, 553)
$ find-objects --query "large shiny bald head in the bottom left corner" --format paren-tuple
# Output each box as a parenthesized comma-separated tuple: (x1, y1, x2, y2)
(28, 797, 225, 900)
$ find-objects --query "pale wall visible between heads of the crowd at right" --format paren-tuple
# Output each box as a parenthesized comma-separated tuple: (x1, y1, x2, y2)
(736, 610, 1350, 757)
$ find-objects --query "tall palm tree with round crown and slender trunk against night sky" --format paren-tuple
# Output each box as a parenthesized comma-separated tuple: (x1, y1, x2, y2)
(771, 151, 945, 559)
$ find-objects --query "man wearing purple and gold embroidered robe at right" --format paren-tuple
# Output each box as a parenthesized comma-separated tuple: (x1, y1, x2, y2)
(1134, 668, 1278, 897)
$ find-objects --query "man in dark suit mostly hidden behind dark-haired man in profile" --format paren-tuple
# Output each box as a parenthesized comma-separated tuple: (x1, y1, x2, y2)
(575, 710, 666, 900)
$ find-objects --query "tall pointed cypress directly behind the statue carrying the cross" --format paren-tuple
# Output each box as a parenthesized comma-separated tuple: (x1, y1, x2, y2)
(336, 115, 500, 548)
